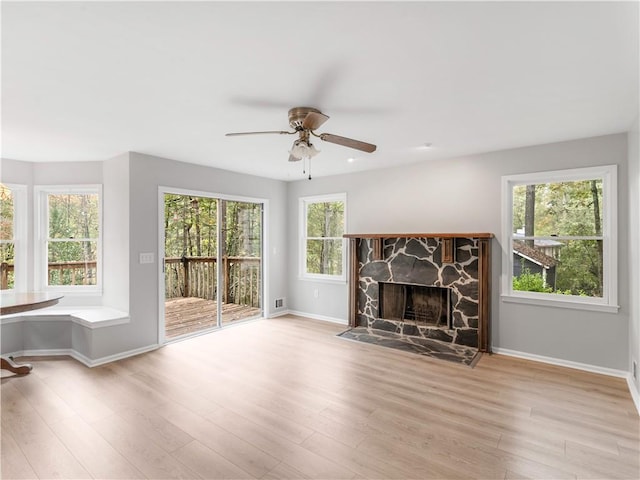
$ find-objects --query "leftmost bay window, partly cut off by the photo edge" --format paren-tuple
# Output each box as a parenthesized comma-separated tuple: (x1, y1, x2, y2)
(0, 184, 27, 291)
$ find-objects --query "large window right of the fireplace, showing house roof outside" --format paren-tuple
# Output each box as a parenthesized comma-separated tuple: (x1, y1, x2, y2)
(502, 165, 617, 311)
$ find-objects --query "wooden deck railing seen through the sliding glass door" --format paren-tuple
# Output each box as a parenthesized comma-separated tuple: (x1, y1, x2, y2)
(164, 257, 261, 307)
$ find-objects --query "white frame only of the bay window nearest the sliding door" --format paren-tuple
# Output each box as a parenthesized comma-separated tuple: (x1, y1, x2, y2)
(34, 184, 103, 295)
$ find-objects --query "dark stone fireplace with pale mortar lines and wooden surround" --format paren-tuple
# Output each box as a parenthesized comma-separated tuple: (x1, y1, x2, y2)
(345, 233, 493, 352)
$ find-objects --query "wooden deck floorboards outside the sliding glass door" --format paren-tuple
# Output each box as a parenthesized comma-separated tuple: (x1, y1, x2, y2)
(164, 297, 262, 339)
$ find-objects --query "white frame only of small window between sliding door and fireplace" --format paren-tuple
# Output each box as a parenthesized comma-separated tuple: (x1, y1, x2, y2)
(298, 193, 348, 283)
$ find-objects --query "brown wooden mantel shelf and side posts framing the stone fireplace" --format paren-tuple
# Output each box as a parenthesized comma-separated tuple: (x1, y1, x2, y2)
(343, 232, 494, 352)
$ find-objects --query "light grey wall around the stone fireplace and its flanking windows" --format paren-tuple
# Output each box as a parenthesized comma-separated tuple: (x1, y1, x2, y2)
(288, 134, 629, 371)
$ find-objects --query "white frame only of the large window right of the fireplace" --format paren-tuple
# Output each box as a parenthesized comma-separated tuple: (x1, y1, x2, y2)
(501, 165, 619, 313)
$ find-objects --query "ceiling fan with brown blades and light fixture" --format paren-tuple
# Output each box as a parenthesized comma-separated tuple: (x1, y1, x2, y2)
(226, 107, 376, 162)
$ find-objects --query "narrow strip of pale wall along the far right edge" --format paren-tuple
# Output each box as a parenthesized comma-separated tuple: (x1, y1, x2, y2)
(628, 117, 640, 400)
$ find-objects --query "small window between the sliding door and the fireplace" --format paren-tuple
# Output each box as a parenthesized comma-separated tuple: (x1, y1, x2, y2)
(300, 194, 347, 281)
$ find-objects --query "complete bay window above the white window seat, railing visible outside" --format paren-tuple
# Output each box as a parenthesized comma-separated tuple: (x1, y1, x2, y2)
(36, 185, 102, 291)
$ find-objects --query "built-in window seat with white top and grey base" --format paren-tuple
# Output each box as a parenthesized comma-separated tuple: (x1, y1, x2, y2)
(0, 305, 129, 367)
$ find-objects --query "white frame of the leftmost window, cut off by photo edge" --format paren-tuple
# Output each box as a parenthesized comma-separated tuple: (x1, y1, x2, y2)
(2, 183, 29, 293)
